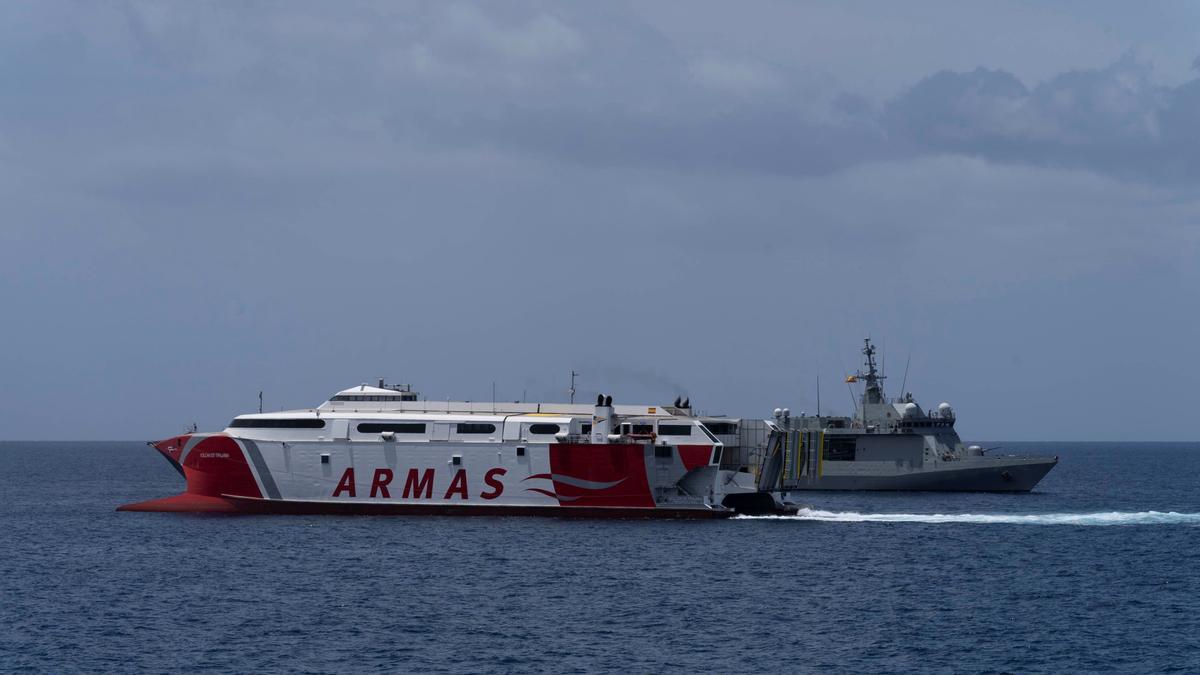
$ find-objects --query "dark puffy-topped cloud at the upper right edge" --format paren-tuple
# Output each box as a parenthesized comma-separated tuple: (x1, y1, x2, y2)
(881, 56, 1200, 184)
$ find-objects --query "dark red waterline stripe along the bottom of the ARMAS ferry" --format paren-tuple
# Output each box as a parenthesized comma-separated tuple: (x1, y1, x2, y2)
(116, 494, 733, 519)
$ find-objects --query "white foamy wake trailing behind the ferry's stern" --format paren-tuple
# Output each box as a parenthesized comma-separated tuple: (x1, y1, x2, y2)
(738, 508, 1200, 525)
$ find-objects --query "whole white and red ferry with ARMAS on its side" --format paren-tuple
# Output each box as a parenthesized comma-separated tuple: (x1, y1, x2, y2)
(119, 381, 776, 518)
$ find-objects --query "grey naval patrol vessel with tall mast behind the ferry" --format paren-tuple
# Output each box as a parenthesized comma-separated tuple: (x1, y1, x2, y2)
(704, 339, 1058, 498)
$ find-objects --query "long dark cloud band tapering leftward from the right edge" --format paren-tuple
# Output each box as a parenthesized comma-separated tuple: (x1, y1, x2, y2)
(392, 48, 1200, 185)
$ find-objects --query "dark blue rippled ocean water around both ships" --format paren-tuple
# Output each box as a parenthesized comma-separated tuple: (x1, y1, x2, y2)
(0, 442, 1200, 673)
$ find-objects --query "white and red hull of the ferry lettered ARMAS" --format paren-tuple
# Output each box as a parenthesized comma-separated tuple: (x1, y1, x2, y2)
(118, 434, 734, 519)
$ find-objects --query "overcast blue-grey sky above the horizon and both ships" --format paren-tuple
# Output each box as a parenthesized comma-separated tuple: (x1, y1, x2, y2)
(0, 0, 1200, 440)
